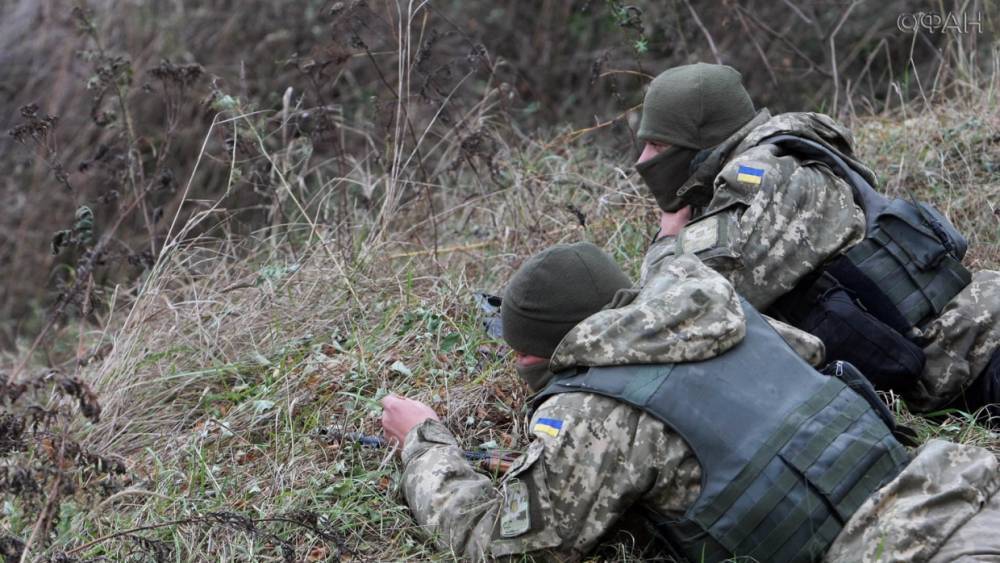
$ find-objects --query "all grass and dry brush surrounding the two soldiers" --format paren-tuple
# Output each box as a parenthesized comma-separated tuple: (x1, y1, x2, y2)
(0, 0, 1000, 563)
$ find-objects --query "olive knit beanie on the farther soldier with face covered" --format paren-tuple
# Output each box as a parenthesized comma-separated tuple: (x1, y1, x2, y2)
(639, 63, 756, 149)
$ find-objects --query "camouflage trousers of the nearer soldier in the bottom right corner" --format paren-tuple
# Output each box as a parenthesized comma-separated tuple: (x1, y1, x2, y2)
(824, 440, 1000, 563)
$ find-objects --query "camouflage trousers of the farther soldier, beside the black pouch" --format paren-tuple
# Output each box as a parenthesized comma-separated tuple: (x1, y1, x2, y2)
(905, 270, 1000, 412)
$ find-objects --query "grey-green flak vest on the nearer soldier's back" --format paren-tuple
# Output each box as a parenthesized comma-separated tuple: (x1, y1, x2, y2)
(533, 302, 909, 563)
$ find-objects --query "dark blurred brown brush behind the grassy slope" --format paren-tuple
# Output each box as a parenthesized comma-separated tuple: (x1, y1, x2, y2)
(0, 0, 998, 349)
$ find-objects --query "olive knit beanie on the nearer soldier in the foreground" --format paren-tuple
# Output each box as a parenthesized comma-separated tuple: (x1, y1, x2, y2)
(500, 242, 632, 358)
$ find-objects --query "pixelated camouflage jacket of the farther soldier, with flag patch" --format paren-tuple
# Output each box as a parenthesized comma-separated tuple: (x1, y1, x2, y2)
(644, 110, 875, 310)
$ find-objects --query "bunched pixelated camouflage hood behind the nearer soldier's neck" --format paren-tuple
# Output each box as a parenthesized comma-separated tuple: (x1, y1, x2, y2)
(551, 254, 746, 372)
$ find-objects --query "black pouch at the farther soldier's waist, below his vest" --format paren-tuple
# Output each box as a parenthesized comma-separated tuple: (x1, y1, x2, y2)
(775, 274, 926, 393)
